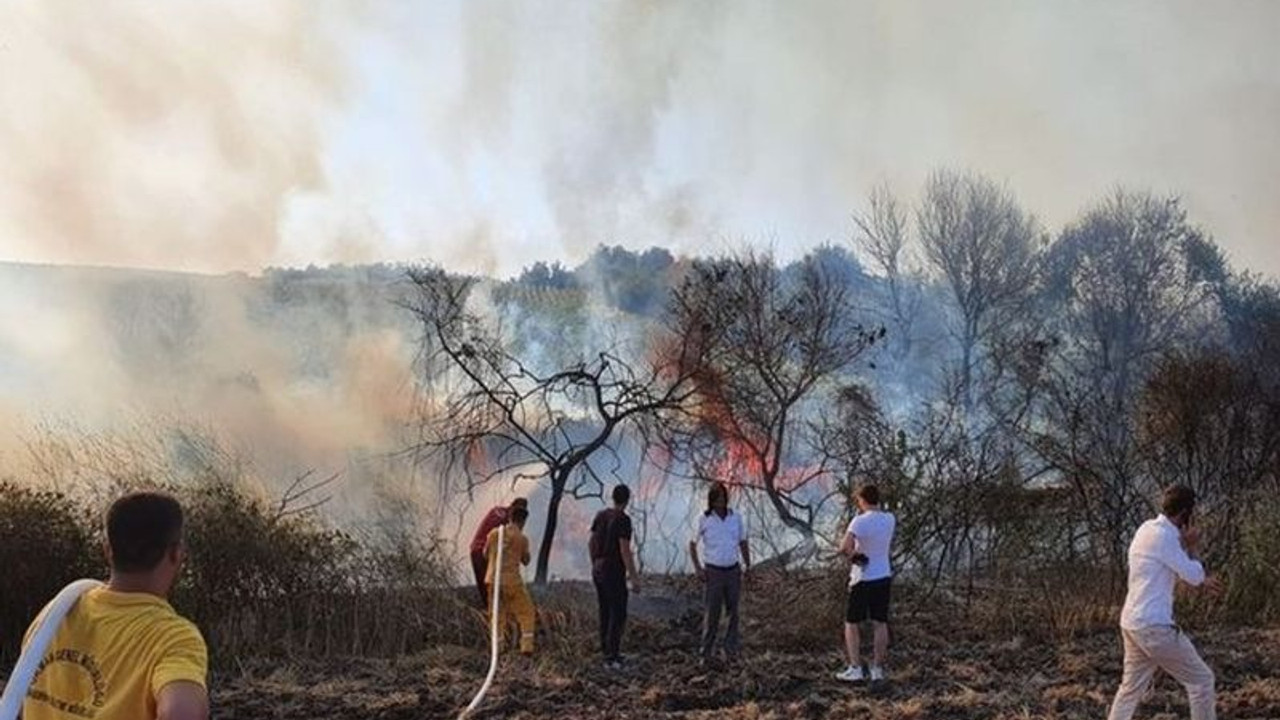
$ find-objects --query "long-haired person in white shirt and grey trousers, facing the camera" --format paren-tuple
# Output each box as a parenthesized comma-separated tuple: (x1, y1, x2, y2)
(689, 483, 751, 662)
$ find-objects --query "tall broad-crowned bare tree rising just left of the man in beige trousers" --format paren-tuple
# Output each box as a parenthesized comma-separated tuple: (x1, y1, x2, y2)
(1029, 191, 1216, 583)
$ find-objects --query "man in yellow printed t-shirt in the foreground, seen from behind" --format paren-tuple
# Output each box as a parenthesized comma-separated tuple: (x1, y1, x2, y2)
(22, 492, 209, 720)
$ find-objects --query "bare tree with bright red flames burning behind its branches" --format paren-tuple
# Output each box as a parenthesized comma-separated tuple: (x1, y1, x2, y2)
(667, 254, 884, 537)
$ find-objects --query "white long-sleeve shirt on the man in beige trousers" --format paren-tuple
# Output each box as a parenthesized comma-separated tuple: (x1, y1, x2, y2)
(1120, 515, 1204, 630)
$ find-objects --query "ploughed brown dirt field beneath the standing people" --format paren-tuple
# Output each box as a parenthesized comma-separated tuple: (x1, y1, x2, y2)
(214, 579, 1280, 720)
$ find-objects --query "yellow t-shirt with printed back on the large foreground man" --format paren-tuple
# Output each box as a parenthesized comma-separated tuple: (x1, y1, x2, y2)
(22, 588, 209, 720)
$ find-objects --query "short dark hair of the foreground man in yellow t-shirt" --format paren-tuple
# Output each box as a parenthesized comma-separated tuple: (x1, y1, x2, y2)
(106, 492, 182, 573)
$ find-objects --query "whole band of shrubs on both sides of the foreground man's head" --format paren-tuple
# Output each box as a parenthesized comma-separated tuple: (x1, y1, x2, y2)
(0, 477, 471, 666)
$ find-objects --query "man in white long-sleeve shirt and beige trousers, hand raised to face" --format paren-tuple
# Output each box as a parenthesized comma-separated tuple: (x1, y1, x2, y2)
(1108, 486, 1221, 720)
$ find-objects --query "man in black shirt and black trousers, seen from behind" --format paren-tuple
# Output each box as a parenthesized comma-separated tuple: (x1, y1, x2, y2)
(590, 486, 640, 670)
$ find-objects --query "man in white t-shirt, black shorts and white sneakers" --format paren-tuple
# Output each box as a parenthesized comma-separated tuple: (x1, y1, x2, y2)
(836, 486, 897, 683)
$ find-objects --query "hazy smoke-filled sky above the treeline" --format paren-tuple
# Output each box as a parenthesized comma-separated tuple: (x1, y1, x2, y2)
(0, 0, 1280, 275)
